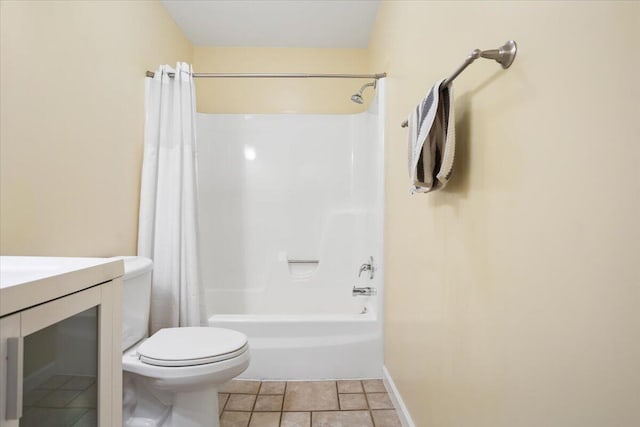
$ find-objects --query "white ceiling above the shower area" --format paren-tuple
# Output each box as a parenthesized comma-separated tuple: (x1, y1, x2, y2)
(161, 0, 380, 48)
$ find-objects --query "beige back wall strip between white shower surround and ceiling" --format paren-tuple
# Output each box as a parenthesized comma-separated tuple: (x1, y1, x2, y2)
(193, 46, 373, 114)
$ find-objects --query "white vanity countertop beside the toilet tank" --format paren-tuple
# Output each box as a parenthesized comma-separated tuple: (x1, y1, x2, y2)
(0, 256, 124, 316)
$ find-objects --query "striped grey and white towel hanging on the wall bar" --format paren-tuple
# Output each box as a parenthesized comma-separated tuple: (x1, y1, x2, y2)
(408, 79, 456, 194)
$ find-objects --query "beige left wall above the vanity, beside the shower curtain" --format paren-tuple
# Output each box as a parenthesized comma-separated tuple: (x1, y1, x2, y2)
(0, 1, 192, 256)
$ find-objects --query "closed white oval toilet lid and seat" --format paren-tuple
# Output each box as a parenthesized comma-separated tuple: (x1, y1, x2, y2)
(138, 326, 249, 366)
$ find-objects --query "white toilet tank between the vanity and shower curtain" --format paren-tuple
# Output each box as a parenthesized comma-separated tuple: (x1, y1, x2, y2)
(116, 256, 153, 351)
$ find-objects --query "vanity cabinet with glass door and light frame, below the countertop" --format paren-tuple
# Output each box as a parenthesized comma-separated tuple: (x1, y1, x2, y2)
(0, 260, 122, 427)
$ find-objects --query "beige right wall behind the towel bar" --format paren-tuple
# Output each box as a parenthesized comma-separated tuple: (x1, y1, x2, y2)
(370, 1, 640, 427)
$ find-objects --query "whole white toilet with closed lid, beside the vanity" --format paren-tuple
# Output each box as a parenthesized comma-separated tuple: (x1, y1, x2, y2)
(119, 257, 250, 427)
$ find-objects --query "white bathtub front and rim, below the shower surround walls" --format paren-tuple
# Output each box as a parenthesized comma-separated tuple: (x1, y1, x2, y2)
(209, 304, 383, 380)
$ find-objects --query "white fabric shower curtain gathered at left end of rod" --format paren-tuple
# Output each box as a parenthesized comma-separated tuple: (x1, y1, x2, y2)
(138, 63, 204, 333)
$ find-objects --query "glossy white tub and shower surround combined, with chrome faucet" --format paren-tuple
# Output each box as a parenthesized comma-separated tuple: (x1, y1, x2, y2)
(197, 79, 384, 379)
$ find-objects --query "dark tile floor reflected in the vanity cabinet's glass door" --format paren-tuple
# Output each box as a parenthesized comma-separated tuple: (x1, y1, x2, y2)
(20, 375, 98, 427)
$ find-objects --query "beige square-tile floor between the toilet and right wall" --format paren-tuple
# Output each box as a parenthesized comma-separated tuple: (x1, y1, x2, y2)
(219, 379, 401, 427)
